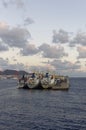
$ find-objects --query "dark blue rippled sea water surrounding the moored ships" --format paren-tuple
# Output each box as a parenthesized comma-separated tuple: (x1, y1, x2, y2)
(0, 78, 86, 130)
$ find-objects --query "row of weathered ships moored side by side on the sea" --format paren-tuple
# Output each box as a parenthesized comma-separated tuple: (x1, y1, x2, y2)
(18, 73, 70, 90)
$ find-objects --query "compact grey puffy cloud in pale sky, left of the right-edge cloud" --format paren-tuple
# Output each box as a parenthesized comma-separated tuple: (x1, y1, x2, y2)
(52, 29, 69, 43)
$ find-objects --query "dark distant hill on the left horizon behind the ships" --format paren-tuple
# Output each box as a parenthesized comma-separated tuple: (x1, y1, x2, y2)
(0, 69, 28, 75)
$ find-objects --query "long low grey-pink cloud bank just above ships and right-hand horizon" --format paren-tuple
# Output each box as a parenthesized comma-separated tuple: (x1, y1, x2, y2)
(29, 60, 82, 77)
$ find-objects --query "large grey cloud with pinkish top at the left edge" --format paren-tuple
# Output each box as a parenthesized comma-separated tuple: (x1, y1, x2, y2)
(0, 22, 31, 48)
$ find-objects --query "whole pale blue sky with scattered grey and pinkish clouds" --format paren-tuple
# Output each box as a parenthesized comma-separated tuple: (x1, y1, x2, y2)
(0, 0, 86, 77)
